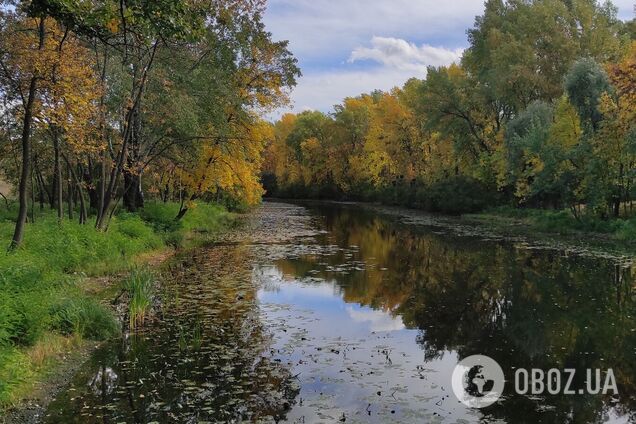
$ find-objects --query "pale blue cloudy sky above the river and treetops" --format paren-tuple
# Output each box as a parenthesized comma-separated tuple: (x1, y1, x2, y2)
(264, 0, 634, 116)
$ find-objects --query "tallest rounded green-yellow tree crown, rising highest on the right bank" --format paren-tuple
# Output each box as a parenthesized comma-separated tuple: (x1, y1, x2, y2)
(462, 0, 624, 113)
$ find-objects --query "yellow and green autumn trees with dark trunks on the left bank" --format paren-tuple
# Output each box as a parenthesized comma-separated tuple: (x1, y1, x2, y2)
(0, 0, 299, 248)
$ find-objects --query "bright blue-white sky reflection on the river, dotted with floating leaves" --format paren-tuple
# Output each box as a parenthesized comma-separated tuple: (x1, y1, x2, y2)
(255, 266, 484, 423)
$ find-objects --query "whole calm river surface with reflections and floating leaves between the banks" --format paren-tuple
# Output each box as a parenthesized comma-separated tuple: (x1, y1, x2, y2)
(46, 203, 636, 423)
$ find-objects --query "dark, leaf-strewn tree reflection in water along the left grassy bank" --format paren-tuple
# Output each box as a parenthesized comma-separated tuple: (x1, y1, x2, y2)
(44, 247, 299, 423)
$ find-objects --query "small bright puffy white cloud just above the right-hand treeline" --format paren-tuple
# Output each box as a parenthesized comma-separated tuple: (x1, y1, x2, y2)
(349, 37, 464, 73)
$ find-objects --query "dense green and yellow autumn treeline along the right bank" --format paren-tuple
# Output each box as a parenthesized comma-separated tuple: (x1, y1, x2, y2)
(264, 0, 636, 219)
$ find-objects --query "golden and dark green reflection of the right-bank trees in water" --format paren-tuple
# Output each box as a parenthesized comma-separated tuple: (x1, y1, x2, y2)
(277, 205, 636, 423)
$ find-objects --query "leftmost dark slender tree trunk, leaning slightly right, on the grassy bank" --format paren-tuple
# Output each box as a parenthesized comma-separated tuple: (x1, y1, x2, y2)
(9, 18, 44, 250)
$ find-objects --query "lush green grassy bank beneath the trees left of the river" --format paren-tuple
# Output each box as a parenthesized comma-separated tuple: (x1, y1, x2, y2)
(0, 203, 233, 411)
